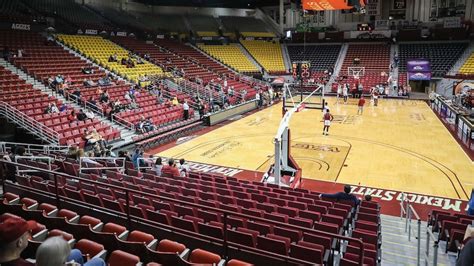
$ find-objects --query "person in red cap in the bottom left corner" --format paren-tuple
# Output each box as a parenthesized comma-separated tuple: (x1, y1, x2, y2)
(0, 218, 36, 266)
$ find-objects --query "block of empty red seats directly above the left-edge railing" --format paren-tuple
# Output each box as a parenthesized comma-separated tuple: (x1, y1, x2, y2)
(0, 67, 120, 146)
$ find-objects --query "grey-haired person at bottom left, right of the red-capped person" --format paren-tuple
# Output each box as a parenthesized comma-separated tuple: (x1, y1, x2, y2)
(36, 236, 105, 266)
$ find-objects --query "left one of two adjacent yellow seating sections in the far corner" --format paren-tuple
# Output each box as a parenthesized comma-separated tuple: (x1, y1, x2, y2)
(198, 43, 259, 73)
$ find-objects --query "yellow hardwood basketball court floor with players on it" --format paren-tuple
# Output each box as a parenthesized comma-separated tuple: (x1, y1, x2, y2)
(158, 98, 474, 199)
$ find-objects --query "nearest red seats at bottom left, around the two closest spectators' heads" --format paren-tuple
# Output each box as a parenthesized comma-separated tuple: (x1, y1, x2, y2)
(0, 193, 248, 266)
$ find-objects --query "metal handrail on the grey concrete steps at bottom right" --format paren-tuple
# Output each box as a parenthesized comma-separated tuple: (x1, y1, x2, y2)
(400, 193, 439, 266)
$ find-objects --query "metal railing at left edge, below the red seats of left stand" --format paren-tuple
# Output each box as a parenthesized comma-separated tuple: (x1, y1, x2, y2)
(0, 101, 59, 144)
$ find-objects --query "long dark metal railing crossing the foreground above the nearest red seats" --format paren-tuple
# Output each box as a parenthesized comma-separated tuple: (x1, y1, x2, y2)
(0, 159, 365, 266)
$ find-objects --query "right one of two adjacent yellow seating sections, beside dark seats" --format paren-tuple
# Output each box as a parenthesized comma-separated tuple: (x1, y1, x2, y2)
(240, 40, 286, 74)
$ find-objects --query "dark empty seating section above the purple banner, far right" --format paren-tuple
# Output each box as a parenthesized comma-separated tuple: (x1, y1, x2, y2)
(399, 42, 467, 77)
